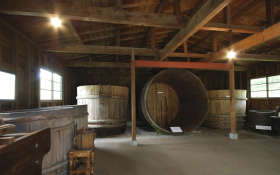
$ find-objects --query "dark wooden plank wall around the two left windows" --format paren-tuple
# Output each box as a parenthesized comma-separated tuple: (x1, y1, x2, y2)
(0, 20, 67, 111)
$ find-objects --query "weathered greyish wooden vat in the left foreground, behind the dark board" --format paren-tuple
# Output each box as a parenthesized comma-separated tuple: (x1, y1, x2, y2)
(0, 105, 88, 175)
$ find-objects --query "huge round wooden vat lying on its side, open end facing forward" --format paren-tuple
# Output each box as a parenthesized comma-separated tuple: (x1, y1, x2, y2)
(140, 69, 208, 133)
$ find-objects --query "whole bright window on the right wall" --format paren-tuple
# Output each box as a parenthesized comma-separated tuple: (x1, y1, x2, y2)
(250, 75, 280, 98)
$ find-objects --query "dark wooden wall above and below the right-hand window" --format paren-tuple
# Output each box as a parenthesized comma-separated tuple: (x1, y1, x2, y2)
(247, 63, 280, 110)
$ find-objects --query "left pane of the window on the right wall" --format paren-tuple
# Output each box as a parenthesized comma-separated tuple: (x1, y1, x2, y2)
(250, 77, 267, 98)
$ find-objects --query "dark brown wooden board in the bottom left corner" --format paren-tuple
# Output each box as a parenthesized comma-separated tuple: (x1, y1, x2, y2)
(0, 128, 51, 175)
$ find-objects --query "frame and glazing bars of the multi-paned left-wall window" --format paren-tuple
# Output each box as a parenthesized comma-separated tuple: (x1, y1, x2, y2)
(39, 67, 64, 102)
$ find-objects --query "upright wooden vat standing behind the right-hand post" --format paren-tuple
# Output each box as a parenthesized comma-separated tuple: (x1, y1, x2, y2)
(204, 89, 247, 129)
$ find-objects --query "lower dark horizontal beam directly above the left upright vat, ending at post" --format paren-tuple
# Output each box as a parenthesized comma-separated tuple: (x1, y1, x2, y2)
(67, 61, 130, 68)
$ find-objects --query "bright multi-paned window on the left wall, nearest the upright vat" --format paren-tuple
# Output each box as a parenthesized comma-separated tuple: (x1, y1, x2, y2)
(40, 69, 63, 100)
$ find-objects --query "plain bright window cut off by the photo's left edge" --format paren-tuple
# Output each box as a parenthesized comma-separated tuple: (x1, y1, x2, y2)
(0, 71, 16, 100)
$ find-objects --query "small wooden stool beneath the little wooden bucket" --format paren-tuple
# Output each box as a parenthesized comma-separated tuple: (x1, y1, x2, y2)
(69, 148, 95, 175)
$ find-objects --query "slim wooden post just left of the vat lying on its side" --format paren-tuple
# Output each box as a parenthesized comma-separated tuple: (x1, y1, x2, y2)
(130, 49, 137, 145)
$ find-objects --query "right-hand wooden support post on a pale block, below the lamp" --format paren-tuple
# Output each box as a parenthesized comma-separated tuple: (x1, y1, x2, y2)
(229, 60, 238, 140)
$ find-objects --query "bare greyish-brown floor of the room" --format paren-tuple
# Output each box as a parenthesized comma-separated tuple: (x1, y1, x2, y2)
(95, 129, 280, 175)
